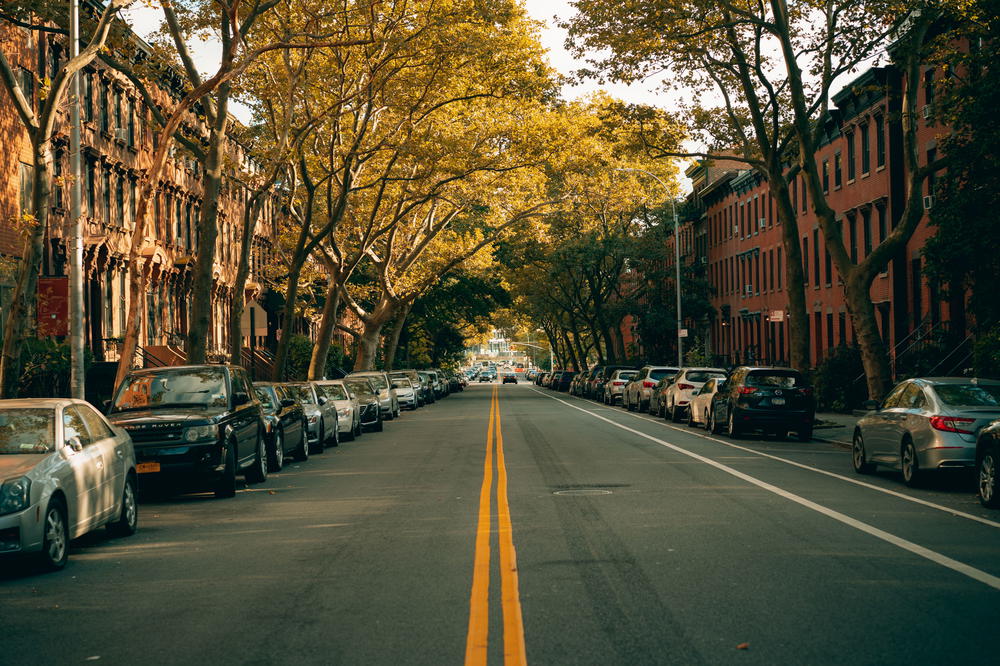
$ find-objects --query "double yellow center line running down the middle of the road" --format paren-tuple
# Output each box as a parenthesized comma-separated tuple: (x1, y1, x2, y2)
(465, 386, 528, 666)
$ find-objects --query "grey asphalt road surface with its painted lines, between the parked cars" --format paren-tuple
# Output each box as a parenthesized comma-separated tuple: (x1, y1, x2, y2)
(0, 383, 1000, 665)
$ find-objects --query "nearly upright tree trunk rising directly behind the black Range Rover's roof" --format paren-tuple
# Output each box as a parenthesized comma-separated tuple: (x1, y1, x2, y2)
(185, 92, 229, 364)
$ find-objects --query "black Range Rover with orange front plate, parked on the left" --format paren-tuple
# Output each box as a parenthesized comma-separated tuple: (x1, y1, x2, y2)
(108, 365, 267, 497)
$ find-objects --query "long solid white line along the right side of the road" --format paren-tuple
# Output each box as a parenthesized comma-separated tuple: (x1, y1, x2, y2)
(532, 389, 1000, 590)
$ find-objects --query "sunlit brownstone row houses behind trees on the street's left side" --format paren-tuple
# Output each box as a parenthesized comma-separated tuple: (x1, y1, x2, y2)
(0, 18, 290, 376)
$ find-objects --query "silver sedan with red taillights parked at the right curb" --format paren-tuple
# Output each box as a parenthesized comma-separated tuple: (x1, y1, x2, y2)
(851, 377, 1000, 486)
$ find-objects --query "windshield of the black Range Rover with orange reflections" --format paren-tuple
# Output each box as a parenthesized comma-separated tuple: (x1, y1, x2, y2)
(110, 368, 229, 412)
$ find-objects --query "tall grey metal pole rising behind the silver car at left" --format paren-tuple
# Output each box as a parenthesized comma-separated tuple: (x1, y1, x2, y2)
(65, 0, 86, 400)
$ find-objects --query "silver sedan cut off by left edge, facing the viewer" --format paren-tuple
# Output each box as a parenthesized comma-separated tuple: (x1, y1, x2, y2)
(0, 398, 139, 569)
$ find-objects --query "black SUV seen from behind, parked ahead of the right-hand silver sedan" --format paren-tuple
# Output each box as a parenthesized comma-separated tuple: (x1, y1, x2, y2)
(708, 367, 816, 442)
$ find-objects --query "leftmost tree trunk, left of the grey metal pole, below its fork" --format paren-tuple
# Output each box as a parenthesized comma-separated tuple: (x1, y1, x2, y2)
(0, 141, 52, 398)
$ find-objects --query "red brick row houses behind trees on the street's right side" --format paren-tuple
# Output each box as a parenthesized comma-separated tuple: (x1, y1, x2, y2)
(624, 66, 971, 374)
